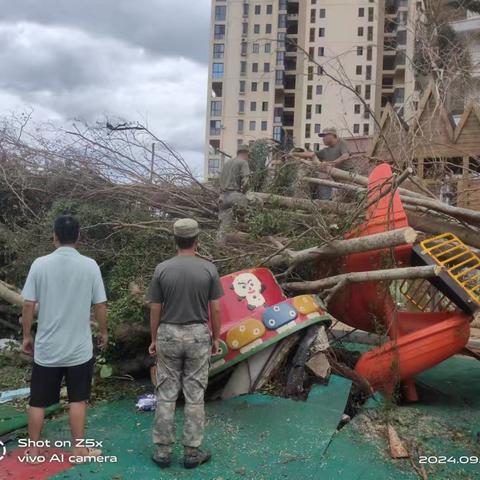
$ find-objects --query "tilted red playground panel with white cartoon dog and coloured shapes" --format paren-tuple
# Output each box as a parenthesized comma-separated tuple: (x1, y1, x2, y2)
(210, 268, 333, 376)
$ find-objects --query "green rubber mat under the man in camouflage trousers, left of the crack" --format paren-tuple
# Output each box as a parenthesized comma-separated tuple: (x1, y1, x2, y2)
(45, 376, 351, 480)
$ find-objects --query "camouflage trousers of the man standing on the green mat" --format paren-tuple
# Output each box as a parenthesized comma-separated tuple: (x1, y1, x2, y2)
(153, 323, 212, 454)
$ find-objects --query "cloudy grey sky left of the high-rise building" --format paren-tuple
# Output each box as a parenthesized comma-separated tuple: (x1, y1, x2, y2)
(0, 0, 210, 173)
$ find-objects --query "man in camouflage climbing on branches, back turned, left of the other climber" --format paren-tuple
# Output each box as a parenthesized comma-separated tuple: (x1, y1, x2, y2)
(217, 145, 250, 243)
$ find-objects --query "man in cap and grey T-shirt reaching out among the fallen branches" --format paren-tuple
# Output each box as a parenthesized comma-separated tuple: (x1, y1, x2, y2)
(294, 127, 352, 200)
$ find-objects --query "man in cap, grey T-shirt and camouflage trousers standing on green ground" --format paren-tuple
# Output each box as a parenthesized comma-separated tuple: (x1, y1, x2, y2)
(147, 218, 223, 468)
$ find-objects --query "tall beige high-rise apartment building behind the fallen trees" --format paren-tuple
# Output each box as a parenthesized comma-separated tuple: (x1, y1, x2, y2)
(205, 0, 420, 178)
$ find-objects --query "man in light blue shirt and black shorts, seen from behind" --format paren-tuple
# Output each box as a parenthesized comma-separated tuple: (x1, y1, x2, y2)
(22, 215, 108, 463)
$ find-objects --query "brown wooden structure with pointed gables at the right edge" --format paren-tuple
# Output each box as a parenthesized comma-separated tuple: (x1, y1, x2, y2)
(369, 84, 480, 210)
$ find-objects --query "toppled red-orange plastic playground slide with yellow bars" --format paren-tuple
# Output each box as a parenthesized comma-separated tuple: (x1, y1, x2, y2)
(330, 164, 472, 401)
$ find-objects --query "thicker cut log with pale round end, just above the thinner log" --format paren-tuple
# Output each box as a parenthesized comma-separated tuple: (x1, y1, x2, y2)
(267, 227, 417, 267)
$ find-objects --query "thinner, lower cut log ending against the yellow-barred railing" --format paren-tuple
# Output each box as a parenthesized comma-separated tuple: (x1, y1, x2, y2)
(283, 265, 442, 292)
